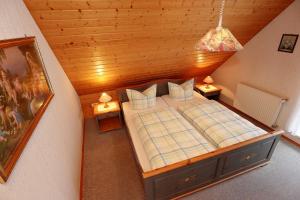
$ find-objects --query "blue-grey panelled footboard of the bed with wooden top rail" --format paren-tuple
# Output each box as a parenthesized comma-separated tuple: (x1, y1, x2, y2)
(143, 132, 281, 200)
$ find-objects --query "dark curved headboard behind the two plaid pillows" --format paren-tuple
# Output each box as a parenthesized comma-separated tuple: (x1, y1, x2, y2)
(117, 79, 186, 103)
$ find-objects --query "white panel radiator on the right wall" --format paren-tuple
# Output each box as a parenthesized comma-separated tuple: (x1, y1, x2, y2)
(233, 83, 286, 128)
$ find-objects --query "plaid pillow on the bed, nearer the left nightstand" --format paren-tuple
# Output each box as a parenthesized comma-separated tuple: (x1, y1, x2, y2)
(126, 84, 157, 110)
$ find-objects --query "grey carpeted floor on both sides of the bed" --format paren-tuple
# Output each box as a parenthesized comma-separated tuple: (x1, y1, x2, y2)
(83, 119, 300, 200)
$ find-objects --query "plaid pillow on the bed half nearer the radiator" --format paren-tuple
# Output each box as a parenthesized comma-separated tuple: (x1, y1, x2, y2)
(168, 79, 194, 101)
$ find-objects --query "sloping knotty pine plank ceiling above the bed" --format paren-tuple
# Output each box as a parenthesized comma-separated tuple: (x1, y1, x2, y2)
(24, 0, 293, 95)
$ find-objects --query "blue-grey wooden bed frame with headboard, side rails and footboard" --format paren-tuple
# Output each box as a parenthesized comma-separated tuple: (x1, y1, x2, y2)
(118, 79, 283, 200)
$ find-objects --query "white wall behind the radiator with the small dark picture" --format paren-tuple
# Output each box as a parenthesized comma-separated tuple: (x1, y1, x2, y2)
(212, 0, 300, 129)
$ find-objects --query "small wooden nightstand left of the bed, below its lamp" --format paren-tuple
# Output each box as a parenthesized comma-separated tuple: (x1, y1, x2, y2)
(92, 101, 123, 132)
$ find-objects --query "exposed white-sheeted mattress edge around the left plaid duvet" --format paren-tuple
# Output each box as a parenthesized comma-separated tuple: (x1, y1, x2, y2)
(122, 97, 168, 172)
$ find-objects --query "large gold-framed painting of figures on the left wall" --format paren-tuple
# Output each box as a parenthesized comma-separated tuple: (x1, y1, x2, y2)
(0, 37, 54, 183)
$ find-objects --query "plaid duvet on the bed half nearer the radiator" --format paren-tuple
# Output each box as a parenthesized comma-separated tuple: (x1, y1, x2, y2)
(178, 101, 267, 147)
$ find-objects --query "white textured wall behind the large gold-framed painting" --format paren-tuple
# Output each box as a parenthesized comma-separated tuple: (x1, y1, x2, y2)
(0, 0, 83, 200)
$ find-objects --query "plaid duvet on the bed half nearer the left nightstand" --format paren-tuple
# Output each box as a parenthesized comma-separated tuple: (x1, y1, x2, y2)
(134, 108, 215, 169)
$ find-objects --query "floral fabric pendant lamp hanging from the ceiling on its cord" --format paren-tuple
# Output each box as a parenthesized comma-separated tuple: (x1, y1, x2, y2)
(196, 0, 243, 52)
